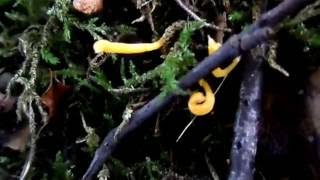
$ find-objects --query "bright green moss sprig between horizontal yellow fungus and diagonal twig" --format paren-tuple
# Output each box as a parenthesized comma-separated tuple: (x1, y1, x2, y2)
(125, 22, 203, 94)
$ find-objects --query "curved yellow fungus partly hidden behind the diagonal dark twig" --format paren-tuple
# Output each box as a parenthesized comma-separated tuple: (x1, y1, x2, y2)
(208, 36, 240, 78)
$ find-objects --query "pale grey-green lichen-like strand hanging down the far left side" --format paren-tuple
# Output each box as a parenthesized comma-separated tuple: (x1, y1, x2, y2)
(7, 24, 48, 179)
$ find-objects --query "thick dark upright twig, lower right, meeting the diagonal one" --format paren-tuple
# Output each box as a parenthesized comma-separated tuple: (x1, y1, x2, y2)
(229, 44, 266, 180)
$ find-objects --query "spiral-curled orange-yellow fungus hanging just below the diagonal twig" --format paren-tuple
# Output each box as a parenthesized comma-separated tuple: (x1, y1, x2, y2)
(188, 79, 215, 116)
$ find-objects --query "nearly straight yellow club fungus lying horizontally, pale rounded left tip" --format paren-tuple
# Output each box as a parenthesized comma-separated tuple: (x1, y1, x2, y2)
(93, 38, 164, 54)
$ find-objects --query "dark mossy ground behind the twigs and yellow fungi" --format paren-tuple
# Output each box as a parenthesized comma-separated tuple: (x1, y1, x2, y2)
(0, 0, 320, 179)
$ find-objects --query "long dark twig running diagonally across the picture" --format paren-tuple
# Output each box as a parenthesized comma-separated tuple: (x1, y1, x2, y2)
(82, 0, 313, 180)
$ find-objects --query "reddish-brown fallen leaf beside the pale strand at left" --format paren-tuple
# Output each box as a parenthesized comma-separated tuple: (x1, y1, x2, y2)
(41, 73, 71, 120)
